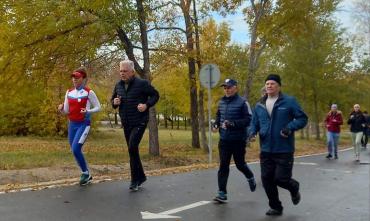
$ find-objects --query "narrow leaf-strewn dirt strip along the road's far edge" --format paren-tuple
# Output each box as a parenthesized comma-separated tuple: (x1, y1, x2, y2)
(0, 144, 342, 193)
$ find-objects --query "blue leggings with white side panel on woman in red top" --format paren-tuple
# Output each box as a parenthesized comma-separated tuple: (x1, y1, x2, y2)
(68, 120, 90, 172)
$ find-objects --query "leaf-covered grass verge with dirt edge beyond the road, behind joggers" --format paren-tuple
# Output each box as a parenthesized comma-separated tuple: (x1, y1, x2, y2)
(0, 128, 350, 188)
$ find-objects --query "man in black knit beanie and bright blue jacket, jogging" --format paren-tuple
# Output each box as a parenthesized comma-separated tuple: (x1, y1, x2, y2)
(250, 74, 307, 216)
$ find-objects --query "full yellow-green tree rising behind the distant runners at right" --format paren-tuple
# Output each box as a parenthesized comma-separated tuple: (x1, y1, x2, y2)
(275, 0, 351, 139)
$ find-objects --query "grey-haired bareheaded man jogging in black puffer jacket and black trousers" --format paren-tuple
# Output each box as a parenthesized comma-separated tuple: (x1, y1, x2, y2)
(111, 60, 159, 191)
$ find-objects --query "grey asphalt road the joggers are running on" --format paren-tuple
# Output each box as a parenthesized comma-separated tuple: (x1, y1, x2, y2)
(0, 150, 370, 221)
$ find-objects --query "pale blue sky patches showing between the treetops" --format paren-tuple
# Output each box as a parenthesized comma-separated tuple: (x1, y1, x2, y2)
(213, 0, 355, 44)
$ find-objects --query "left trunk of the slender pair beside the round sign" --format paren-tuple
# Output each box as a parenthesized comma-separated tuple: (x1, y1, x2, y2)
(181, 0, 200, 148)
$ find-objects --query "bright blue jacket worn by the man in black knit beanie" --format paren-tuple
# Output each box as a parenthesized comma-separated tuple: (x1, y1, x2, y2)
(250, 93, 308, 153)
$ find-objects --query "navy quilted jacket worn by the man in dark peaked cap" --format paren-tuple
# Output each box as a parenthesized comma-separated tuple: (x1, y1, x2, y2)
(215, 94, 252, 140)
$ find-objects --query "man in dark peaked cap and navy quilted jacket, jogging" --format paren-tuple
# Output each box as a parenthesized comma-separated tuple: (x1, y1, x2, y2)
(213, 79, 256, 203)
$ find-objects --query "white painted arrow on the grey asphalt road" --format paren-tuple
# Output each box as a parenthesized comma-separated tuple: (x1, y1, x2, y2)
(141, 201, 211, 219)
